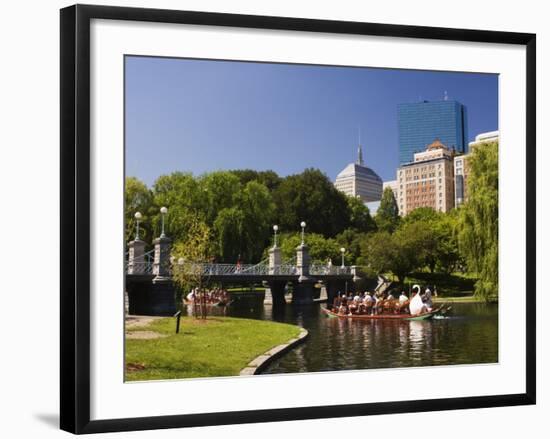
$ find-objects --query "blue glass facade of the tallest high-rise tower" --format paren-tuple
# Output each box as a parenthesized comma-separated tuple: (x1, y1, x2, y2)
(397, 100, 468, 165)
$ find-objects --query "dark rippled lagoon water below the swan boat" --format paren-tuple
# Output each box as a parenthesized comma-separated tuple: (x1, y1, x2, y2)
(182, 303, 498, 373)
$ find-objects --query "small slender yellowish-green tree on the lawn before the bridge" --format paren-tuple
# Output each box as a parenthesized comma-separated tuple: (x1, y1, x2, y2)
(171, 218, 211, 319)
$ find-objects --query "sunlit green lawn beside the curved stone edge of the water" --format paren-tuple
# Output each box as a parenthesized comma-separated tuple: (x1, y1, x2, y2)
(126, 317, 300, 381)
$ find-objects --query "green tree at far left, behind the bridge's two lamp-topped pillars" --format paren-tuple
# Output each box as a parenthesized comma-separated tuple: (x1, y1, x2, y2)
(124, 177, 155, 242)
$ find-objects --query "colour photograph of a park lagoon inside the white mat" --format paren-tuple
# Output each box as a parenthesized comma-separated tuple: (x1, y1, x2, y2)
(124, 55, 499, 383)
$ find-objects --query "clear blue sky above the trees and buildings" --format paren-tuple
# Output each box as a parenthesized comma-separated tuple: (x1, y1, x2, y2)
(125, 57, 498, 185)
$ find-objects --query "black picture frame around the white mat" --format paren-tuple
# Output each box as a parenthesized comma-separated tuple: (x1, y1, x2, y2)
(60, 5, 536, 434)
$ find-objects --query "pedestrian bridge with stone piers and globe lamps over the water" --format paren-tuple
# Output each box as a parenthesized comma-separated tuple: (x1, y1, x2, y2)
(125, 237, 359, 314)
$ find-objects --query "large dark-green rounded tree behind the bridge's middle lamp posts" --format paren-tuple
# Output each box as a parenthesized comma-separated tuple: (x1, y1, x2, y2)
(273, 169, 350, 237)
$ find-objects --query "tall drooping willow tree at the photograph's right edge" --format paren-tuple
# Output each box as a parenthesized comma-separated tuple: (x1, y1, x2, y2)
(458, 142, 498, 300)
